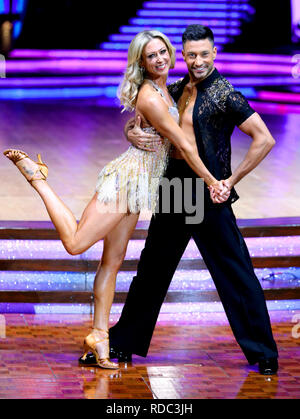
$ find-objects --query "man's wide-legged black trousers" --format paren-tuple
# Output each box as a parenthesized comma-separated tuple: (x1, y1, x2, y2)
(109, 160, 278, 363)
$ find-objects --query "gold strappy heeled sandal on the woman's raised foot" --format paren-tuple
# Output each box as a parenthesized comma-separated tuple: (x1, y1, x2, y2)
(3, 148, 48, 183)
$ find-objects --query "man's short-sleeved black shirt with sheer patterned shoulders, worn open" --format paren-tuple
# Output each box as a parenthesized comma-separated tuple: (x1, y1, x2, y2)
(168, 69, 255, 203)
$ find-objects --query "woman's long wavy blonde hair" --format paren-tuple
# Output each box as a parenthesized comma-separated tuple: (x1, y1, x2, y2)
(118, 30, 176, 112)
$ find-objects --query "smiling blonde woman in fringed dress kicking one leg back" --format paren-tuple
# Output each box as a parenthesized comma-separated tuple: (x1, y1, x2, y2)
(4, 31, 226, 369)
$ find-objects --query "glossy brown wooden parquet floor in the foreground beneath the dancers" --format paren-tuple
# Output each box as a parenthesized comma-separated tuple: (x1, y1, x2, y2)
(0, 311, 300, 400)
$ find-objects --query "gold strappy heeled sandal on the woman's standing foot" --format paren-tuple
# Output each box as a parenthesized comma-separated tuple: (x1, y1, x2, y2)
(82, 328, 119, 370)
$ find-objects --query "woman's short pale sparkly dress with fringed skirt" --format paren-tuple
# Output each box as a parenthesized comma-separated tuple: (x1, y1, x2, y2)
(96, 80, 179, 213)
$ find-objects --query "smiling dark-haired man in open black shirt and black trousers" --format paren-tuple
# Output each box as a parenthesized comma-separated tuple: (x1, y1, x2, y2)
(80, 25, 278, 374)
